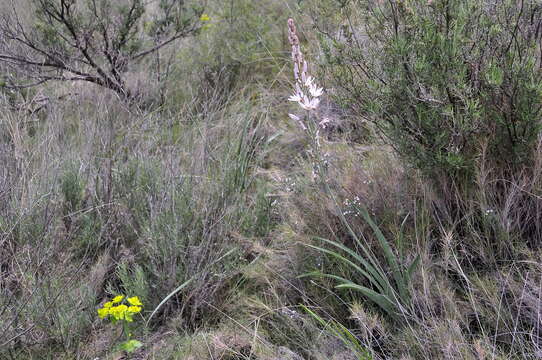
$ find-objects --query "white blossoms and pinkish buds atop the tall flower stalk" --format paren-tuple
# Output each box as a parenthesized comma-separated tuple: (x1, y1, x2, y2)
(288, 19, 324, 130)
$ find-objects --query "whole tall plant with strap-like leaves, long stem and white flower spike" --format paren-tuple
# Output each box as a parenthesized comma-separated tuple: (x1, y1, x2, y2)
(289, 15, 419, 318)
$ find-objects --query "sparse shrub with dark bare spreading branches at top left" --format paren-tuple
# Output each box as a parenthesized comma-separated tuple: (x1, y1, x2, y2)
(0, 0, 205, 99)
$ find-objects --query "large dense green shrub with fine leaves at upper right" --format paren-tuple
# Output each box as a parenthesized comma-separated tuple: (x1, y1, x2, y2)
(316, 0, 542, 187)
